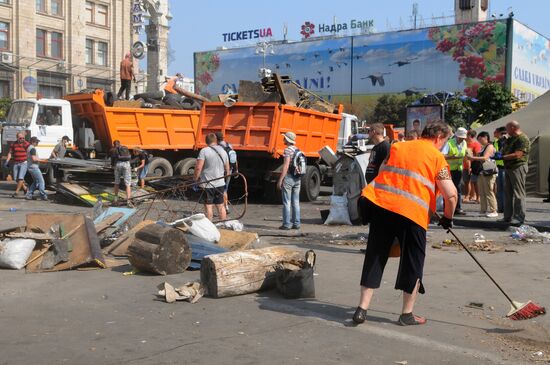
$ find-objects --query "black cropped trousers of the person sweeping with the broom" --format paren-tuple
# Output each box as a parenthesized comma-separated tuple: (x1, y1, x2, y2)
(361, 203, 426, 294)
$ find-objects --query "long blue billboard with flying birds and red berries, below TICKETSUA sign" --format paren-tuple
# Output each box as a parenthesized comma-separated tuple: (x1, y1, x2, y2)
(195, 20, 507, 116)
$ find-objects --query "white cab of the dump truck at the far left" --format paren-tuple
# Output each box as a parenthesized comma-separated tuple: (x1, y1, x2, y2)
(2, 99, 73, 160)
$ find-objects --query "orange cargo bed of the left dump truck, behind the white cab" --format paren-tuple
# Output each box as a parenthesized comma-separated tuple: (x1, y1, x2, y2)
(65, 90, 200, 151)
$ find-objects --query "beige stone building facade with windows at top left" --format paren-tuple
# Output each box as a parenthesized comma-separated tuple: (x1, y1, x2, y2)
(0, 0, 137, 98)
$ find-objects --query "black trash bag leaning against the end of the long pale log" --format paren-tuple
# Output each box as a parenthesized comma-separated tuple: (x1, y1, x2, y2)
(275, 250, 315, 299)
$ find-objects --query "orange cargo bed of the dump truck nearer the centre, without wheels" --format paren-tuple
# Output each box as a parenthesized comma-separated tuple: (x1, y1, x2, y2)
(197, 102, 342, 158)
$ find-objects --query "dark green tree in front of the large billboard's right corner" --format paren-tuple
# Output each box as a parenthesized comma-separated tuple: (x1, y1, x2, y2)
(474, 81, 514, 124)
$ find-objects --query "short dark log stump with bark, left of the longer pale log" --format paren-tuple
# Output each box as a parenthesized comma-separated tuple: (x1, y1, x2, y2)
(128, 224, 191, 275)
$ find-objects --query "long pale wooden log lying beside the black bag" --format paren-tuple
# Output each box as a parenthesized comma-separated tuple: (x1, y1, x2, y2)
(201, 246, 304, 298)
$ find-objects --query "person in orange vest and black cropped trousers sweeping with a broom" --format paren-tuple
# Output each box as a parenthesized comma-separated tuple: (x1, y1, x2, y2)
(353, 121, 457, 326)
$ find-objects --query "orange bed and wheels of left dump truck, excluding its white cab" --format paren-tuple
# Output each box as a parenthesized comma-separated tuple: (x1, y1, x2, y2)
(64, 90, 200, 176)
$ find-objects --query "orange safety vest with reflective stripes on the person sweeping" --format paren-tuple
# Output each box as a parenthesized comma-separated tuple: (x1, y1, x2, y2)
(361, 139, 449, 230)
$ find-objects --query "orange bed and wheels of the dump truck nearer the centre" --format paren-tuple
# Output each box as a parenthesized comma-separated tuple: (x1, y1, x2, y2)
(197, 102, 342, 201)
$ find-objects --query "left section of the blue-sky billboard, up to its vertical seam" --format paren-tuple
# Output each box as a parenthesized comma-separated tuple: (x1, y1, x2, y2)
(195, 37, 351, 99)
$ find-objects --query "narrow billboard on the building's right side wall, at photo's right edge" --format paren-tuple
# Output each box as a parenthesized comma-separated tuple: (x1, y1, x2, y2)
(510, 21, 550, 102)
